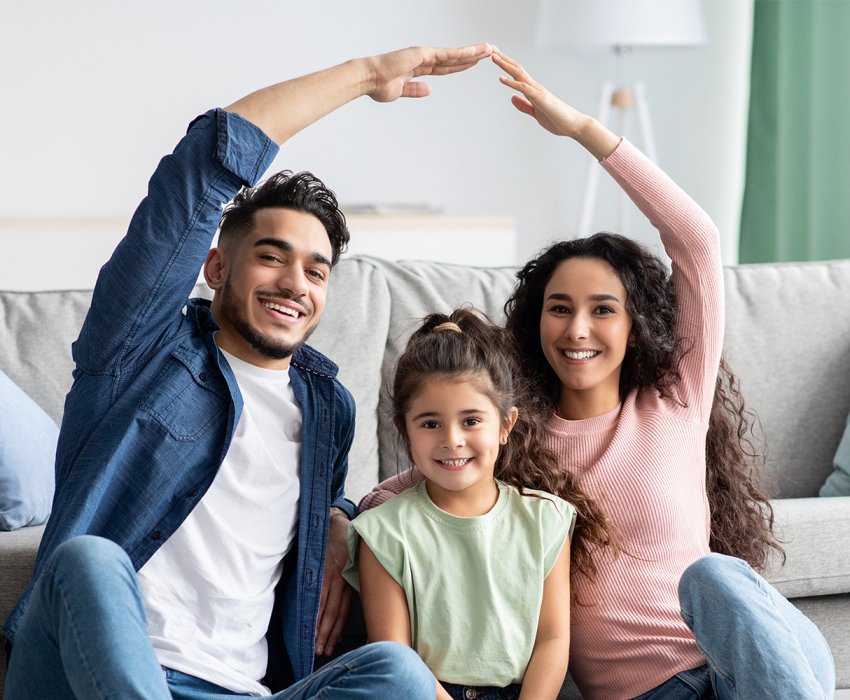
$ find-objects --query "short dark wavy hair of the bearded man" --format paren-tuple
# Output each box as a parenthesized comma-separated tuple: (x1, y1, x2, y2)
(219, 170, 350, 265)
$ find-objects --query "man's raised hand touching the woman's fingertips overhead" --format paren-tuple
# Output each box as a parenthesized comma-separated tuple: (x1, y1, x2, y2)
(364, 44, 493, 102)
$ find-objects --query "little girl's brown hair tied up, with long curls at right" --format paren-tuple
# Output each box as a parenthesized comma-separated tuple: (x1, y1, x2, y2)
(392, 307, 611, 578)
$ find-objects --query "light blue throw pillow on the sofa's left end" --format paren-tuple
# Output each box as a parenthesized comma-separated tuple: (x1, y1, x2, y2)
(0, 371, 59, 530)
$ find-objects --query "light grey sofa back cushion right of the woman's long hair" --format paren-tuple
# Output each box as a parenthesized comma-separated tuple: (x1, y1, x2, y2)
(725, 260, 850, 498)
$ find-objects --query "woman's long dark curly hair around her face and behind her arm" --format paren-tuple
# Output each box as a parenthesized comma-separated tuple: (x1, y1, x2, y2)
(505, 233, 782, 569)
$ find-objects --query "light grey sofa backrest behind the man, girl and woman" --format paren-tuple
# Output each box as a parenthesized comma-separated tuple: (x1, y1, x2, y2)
(0, 256, 850, 501)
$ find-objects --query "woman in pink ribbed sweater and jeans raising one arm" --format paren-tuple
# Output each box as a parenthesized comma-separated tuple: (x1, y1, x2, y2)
(367, 53, 835, 700)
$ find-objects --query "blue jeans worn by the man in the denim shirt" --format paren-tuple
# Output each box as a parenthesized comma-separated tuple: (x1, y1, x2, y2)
(5, 536, 436, 700)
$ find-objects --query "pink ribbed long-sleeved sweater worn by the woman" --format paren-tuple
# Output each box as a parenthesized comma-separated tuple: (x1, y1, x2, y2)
(361, 141, 724, 700)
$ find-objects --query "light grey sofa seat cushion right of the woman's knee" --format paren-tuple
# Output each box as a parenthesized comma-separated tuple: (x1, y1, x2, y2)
(765, 497, 850, 598)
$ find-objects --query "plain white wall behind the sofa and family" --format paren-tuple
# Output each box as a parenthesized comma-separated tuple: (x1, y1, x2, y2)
(0, 0, 752, 287)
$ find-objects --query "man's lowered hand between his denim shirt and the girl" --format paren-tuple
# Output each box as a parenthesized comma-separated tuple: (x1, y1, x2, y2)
(316, 508, 351, 656)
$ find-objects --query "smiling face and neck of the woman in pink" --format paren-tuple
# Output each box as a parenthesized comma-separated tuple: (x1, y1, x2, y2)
(540, 258, 632, 419)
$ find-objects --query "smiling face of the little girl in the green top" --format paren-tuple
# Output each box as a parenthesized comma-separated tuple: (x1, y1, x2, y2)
(404, 376, 517, 515)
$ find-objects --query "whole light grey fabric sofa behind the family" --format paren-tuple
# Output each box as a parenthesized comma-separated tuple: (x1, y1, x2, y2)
(0, 257, 850, 696)
